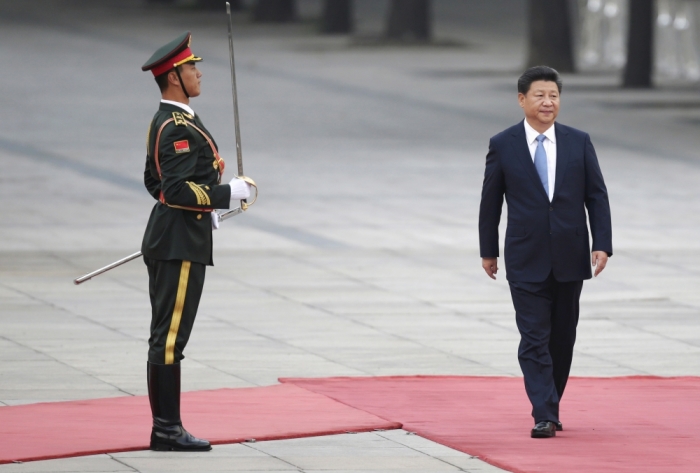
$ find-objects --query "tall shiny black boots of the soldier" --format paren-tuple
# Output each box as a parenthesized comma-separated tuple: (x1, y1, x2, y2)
(148, 362, 211, 452)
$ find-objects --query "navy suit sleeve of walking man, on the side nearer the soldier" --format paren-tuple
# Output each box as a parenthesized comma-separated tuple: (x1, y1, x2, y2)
(479, 140, 506, 258)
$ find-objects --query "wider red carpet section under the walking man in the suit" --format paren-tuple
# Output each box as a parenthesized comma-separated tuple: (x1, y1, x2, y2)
(281, 376, 700, 473)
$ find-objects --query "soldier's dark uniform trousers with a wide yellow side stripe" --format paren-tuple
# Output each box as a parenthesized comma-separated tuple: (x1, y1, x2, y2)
(143, 256, 206, 365)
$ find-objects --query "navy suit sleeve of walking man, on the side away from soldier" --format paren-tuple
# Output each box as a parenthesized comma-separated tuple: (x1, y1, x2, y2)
(584, 135, 612, 256)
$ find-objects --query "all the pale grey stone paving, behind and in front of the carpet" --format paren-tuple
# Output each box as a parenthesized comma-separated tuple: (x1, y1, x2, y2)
(0, 0, 700, 472)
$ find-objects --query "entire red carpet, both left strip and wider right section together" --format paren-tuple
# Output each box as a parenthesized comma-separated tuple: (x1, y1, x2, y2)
(0, 376, 700, 473)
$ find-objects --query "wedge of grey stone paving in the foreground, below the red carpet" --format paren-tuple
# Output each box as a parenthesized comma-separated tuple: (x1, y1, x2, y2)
(0, 430, 503, 473)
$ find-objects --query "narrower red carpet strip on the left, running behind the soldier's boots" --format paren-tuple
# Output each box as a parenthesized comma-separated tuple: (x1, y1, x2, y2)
(0, 384, 401, 463)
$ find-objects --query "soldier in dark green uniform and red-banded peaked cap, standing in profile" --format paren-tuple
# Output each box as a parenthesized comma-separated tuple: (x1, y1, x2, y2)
(141, 32, 250, 451)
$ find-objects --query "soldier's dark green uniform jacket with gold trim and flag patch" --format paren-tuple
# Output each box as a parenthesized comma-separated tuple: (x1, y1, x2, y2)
(141, 103, 231, 265)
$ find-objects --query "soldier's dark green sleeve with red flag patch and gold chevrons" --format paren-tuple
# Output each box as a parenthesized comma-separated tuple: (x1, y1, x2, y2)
(159, 123, 231, 208)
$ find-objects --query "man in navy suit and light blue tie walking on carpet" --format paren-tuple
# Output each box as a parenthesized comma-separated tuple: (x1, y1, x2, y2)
(479, 66, 612, 438)
